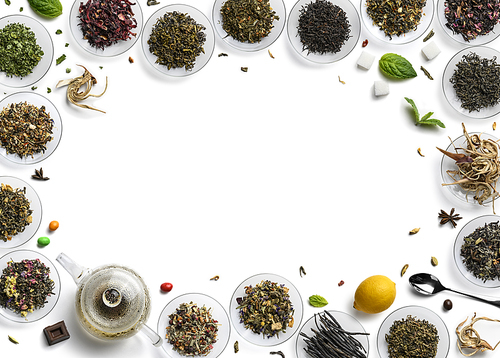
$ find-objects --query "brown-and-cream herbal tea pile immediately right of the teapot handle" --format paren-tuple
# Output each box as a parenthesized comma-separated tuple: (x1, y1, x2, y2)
(165, 302, 218, 356)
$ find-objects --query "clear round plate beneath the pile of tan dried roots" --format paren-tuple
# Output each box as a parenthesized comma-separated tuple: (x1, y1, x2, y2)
(441, 133, 498, 205)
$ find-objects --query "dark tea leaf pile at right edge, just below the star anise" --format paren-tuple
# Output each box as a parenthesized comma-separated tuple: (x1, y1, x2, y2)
(460, 221, 500, 282)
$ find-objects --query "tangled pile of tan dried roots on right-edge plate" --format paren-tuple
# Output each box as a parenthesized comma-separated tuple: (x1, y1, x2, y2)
(437, 123, 500, 210)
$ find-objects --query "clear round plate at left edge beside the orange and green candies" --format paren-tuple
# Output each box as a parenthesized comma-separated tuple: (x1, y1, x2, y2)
(0, 176, 42, 249)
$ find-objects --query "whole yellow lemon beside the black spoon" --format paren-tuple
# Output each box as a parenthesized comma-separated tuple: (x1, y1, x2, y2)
(353, 275, 396, 313)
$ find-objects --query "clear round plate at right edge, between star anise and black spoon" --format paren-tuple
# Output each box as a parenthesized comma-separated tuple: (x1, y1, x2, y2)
(453, 215, 500, 288)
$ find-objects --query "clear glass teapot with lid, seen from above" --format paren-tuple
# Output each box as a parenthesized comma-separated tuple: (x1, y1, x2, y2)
(56, 253, 163, 347)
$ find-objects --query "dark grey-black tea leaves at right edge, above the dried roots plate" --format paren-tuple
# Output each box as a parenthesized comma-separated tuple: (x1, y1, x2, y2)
(450, 51, 500, 113)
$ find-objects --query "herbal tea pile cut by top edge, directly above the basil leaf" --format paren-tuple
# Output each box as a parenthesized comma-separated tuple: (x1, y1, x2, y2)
(366, 0, 426, 40)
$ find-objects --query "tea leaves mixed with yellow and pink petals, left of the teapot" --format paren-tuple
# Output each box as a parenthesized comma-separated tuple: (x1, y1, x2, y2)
(0, 259, 55, 317)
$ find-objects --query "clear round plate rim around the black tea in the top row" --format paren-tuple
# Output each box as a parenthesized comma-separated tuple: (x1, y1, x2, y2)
(287, 0, 361, 63)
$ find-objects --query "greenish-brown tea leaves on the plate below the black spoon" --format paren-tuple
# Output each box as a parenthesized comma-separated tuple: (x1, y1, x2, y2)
(385, 315, 439, 358)
